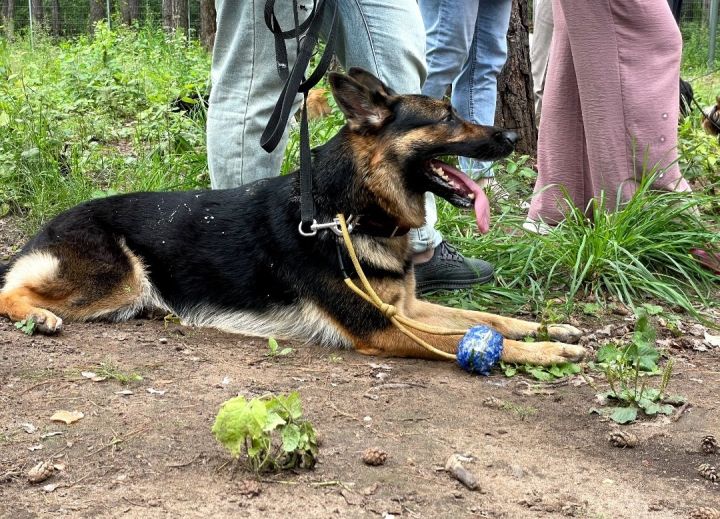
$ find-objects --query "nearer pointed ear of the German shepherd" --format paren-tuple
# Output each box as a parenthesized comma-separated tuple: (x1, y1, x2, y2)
(328, 72, 393, 132)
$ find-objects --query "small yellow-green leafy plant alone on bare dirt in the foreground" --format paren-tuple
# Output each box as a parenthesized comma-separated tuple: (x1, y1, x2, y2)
(212, 392, 318, 472)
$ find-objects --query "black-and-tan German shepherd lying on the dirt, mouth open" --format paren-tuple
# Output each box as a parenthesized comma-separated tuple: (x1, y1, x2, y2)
(0, 69, 584, 364)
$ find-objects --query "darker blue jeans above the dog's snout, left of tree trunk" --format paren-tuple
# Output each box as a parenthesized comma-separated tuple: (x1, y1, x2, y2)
(418, 0, 512, 178)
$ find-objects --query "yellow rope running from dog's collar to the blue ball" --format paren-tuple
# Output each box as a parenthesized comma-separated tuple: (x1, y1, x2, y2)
(337, 214, 467, 360)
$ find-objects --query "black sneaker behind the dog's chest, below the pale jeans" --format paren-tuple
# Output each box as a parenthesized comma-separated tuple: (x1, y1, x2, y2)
(415, 241, 494, 294)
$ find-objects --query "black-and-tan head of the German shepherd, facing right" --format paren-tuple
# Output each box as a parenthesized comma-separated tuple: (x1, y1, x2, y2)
(329, 68, 517, 227)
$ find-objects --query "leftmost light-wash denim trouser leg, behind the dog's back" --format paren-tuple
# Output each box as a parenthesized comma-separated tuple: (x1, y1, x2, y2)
(207, 0, 312, 189)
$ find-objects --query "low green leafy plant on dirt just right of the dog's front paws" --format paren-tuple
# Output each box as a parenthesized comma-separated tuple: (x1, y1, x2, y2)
(590, 312, 684, 424)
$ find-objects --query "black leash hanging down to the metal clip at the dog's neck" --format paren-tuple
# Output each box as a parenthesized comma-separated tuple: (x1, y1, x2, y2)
(260, 0, 337, 236)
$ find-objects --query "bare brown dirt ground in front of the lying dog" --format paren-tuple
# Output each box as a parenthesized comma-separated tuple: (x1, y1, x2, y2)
(0, 220, 720, 519)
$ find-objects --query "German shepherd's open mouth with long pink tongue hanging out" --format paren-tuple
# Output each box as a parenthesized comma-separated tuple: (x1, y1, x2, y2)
(425, 159, 490, 233)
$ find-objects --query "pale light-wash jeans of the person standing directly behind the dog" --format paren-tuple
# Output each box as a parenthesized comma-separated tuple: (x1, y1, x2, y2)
(207, 0, 442, 252)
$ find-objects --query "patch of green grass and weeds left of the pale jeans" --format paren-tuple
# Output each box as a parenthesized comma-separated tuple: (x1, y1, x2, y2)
(0, 24, 209, 231)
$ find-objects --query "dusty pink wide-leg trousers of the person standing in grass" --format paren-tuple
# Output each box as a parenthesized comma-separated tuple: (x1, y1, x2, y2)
(528, 0, 690, 225)
